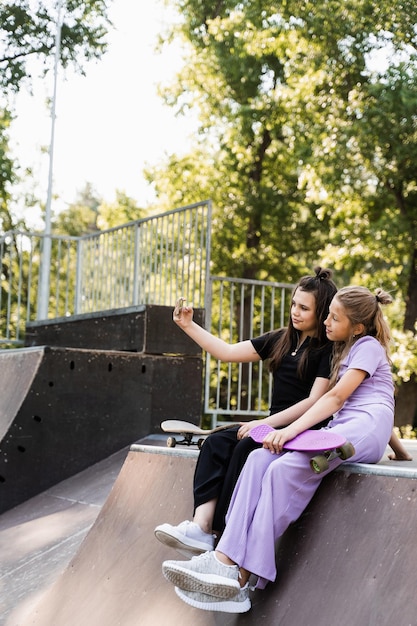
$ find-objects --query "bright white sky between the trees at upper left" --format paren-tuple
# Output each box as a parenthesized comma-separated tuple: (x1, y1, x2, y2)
(10, 0, 191, 222)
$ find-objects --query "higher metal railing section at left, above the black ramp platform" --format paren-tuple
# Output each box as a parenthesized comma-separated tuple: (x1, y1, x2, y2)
(0, 201, 211, 346)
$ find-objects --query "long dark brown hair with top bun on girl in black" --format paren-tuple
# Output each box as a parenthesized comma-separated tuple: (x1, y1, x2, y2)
(270, 267, 337, 376)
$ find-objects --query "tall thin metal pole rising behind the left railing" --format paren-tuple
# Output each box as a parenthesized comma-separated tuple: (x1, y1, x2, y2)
(36, 0, 65, 320)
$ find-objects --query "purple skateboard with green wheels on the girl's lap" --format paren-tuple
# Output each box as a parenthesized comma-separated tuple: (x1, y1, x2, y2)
(249, 424, 355, 474)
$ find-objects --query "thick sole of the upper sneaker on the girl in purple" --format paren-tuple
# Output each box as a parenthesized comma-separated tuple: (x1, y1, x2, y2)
(162, 562, 240, 600)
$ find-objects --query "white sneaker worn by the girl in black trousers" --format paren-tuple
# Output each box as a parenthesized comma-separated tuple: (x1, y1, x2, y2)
(154, 520, 215, 558)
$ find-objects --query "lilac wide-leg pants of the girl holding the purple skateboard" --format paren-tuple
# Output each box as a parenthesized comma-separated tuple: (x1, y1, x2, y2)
(216, 405, 393, 589)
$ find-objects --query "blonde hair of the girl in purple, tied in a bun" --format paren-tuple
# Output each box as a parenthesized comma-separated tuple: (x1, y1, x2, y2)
(330, 286, 392, 386)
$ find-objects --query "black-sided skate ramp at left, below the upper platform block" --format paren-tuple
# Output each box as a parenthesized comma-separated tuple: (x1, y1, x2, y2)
(0, 344, 202, 514)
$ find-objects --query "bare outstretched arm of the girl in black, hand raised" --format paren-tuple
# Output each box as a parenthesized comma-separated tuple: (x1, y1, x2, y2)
(172, 298, 260, 363)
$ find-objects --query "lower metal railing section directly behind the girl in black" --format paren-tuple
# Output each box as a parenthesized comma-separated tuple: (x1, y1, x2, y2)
(204, 276, 294, 428)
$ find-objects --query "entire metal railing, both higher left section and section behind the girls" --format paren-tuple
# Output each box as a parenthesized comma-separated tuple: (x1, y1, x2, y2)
(0, 202, 293, 426)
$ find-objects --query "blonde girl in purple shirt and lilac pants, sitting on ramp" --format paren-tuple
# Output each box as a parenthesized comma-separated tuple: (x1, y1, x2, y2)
(162, 287, 394, 613)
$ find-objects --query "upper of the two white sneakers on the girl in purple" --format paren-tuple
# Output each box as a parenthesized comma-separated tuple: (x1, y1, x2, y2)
(162, 552, 240, 599)
